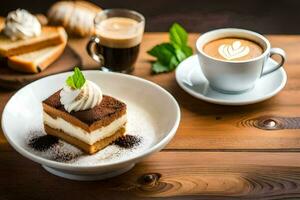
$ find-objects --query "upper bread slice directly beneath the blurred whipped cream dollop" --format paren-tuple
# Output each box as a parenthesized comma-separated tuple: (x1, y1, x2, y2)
(0, 26, 67, 57)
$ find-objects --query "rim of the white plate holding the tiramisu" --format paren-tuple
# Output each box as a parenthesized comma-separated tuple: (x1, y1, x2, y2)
(1, 70, 180, 170)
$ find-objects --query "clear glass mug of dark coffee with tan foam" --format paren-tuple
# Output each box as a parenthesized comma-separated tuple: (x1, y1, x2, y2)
(87, 9, 145, 73)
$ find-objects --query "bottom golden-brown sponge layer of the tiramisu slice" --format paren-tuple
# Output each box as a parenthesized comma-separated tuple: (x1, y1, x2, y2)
(45, 125, 125, 154)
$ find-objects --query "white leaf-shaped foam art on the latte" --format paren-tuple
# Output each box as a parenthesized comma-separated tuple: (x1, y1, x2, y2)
(218, 40, 250, 60)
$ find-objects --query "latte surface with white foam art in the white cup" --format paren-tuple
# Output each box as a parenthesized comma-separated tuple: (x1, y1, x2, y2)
(203, 38, 263, 61)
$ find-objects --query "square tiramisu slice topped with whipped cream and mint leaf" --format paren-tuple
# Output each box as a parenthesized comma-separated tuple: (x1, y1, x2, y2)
(43, 68, 127, 154)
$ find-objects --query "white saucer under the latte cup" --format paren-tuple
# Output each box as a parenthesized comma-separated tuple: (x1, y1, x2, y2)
(176, 55, 287, 105)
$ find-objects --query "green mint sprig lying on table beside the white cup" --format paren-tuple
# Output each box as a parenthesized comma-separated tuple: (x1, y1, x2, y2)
(147, 23, 193, 74)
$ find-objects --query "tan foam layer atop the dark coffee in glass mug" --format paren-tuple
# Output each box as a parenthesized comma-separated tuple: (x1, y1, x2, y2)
(96, 17, 144, 48)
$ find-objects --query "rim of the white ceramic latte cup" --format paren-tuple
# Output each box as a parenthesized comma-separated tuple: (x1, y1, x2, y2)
(196, 28, 271, 63)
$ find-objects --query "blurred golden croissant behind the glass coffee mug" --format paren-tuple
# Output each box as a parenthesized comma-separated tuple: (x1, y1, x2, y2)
(48, 1, 102, 37)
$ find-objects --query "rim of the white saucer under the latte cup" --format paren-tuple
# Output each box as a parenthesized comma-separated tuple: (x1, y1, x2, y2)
(175, 55, 287, 106)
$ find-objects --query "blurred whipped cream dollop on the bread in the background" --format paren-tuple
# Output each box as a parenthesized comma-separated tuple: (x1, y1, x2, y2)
(4, 9, 42, 40)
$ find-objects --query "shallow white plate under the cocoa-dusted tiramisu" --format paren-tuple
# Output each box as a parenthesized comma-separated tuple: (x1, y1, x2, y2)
(2, 71, 180, 180)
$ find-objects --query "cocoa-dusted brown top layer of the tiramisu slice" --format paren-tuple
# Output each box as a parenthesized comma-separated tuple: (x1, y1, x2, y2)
(43, 90, 126, 126)
